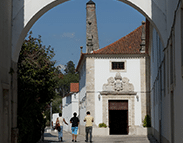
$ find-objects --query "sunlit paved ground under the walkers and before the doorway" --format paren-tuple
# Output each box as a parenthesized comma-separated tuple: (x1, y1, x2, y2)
(40, 130, 158, 143)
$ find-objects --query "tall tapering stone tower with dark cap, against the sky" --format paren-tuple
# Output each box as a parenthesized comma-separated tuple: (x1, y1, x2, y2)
(86, 0, 99, 53)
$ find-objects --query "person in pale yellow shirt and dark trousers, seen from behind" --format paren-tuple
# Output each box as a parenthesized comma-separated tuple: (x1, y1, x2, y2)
(84, 111, 94, 142)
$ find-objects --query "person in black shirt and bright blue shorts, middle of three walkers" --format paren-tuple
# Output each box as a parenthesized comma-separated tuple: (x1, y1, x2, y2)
(70, 112, 79, 142)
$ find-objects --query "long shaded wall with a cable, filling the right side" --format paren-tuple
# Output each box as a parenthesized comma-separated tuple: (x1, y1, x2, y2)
(150, 1, 183, 143)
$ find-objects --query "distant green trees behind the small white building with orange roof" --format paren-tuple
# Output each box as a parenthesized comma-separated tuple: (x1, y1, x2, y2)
(59, 61, 79, 96)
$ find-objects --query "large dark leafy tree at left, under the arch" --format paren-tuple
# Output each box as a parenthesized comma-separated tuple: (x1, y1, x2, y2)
(17, 35, 58, 143)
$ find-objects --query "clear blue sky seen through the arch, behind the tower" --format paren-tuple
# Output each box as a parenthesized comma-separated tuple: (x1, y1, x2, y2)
(30, 0, 145, 66)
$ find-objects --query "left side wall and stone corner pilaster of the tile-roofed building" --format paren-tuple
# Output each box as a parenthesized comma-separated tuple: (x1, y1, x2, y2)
(79, 58, 96, 134)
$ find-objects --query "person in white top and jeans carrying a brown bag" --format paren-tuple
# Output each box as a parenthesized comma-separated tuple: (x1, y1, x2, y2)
(56, 113, 68, 142)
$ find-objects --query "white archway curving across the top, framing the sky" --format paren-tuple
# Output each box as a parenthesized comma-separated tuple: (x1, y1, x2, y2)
(12, 0, 166, 63)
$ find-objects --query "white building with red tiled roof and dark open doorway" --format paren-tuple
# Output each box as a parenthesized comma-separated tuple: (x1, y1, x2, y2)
(77, 23, 149, 135)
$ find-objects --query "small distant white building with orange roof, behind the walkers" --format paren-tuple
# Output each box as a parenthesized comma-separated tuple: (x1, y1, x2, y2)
(62, 83, 79, 132)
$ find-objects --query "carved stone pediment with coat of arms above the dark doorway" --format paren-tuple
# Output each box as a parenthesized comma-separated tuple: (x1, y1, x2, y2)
(101, 72, 136, 95)
